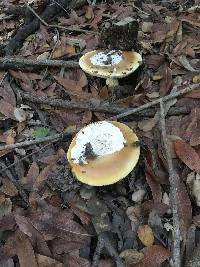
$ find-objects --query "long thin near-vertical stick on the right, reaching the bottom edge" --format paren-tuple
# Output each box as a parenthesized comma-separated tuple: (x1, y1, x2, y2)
(160, 99, 181, 267)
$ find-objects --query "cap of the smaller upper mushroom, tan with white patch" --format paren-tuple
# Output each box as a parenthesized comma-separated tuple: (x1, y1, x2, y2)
(79, 50, 142, 78)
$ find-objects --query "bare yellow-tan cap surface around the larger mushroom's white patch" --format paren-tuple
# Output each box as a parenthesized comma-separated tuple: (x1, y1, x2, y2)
(67, 121, 140, 186)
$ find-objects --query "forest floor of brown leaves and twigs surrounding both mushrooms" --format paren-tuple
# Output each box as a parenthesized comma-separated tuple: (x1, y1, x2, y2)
(0, 0, 200, 267)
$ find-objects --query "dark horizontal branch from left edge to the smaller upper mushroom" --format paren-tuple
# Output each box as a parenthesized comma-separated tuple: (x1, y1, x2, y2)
(0, 57, 79, 70)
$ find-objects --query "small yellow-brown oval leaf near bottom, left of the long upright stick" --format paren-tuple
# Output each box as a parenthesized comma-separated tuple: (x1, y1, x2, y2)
(137, 225, 154, 247)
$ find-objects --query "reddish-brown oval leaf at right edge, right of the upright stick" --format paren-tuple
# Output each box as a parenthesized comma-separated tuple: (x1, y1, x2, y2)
(174, 140, 200, 172)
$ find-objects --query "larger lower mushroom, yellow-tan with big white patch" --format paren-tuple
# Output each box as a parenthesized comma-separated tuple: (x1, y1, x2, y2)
(67, 121, 140, 186)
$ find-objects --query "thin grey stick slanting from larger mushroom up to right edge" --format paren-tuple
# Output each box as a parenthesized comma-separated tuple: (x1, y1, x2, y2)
(109, 83, 200, 120)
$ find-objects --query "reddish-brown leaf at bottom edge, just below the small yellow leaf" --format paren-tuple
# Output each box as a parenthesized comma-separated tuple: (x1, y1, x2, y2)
(134, 245, 171, 267)
